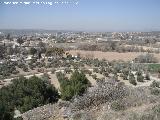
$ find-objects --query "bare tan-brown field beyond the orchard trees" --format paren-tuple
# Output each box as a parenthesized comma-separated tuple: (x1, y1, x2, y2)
(68, 50, 160, 61)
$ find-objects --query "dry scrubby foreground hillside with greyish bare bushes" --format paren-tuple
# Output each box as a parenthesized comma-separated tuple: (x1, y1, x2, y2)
(22, 80, 160, 120)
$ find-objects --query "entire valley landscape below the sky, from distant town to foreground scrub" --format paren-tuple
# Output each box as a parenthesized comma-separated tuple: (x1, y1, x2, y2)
(0, 29, 160, 120)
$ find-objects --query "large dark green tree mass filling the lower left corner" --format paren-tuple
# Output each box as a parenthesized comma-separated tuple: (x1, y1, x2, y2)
(0, 76, 59, 120)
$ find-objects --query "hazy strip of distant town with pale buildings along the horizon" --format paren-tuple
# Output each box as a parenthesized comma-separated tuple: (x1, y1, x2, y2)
(0, 30, 160, 51)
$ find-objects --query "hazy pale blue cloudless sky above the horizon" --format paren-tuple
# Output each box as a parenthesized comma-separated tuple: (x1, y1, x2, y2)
(0, 0, 160, 31)
